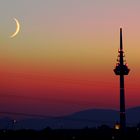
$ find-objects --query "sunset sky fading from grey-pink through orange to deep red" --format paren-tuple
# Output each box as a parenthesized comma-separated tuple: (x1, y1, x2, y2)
(0, 0, 140, 115)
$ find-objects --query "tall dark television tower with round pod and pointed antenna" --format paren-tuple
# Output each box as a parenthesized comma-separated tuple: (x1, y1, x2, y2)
(114, 28, 130, 132)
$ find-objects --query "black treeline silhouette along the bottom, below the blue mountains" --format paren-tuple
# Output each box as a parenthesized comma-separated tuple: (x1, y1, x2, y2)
(0, 125, 140, 140)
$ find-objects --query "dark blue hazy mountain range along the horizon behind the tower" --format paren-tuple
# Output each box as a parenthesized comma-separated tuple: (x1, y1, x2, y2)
(0, 107, 140, 130)
